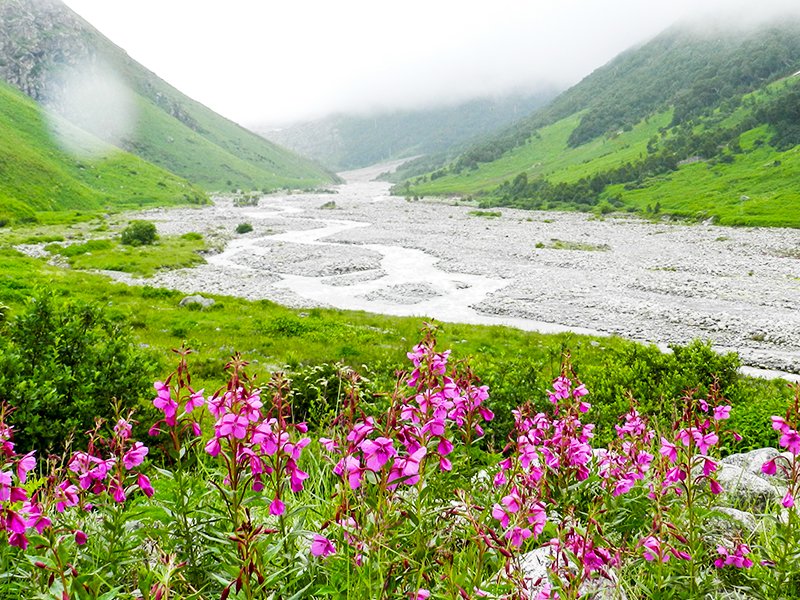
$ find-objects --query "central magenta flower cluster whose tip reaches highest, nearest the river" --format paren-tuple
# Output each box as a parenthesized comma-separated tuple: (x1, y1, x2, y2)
(319, 330, 494, 565)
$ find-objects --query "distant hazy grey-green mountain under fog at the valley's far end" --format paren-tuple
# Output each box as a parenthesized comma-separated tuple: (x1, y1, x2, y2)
(256, 91, 555, 171)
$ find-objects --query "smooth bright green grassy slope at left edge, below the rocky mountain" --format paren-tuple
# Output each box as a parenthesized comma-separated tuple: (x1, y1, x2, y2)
(0, 82, 206, 224)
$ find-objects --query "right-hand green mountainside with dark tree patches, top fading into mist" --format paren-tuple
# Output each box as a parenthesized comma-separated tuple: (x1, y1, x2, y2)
(397, 17, 800, 227)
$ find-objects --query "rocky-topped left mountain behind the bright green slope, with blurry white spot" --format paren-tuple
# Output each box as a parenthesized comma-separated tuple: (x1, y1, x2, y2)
(0, 0, 335, 190)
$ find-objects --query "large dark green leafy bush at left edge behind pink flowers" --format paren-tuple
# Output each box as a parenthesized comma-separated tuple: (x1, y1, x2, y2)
(0, 292, 156, 452)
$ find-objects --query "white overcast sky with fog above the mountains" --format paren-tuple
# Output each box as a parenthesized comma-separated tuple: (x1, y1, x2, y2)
(61, 0, 800, 125)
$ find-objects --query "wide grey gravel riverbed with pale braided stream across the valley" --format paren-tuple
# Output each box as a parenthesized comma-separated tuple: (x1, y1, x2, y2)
(108, 161, 800, 373)
